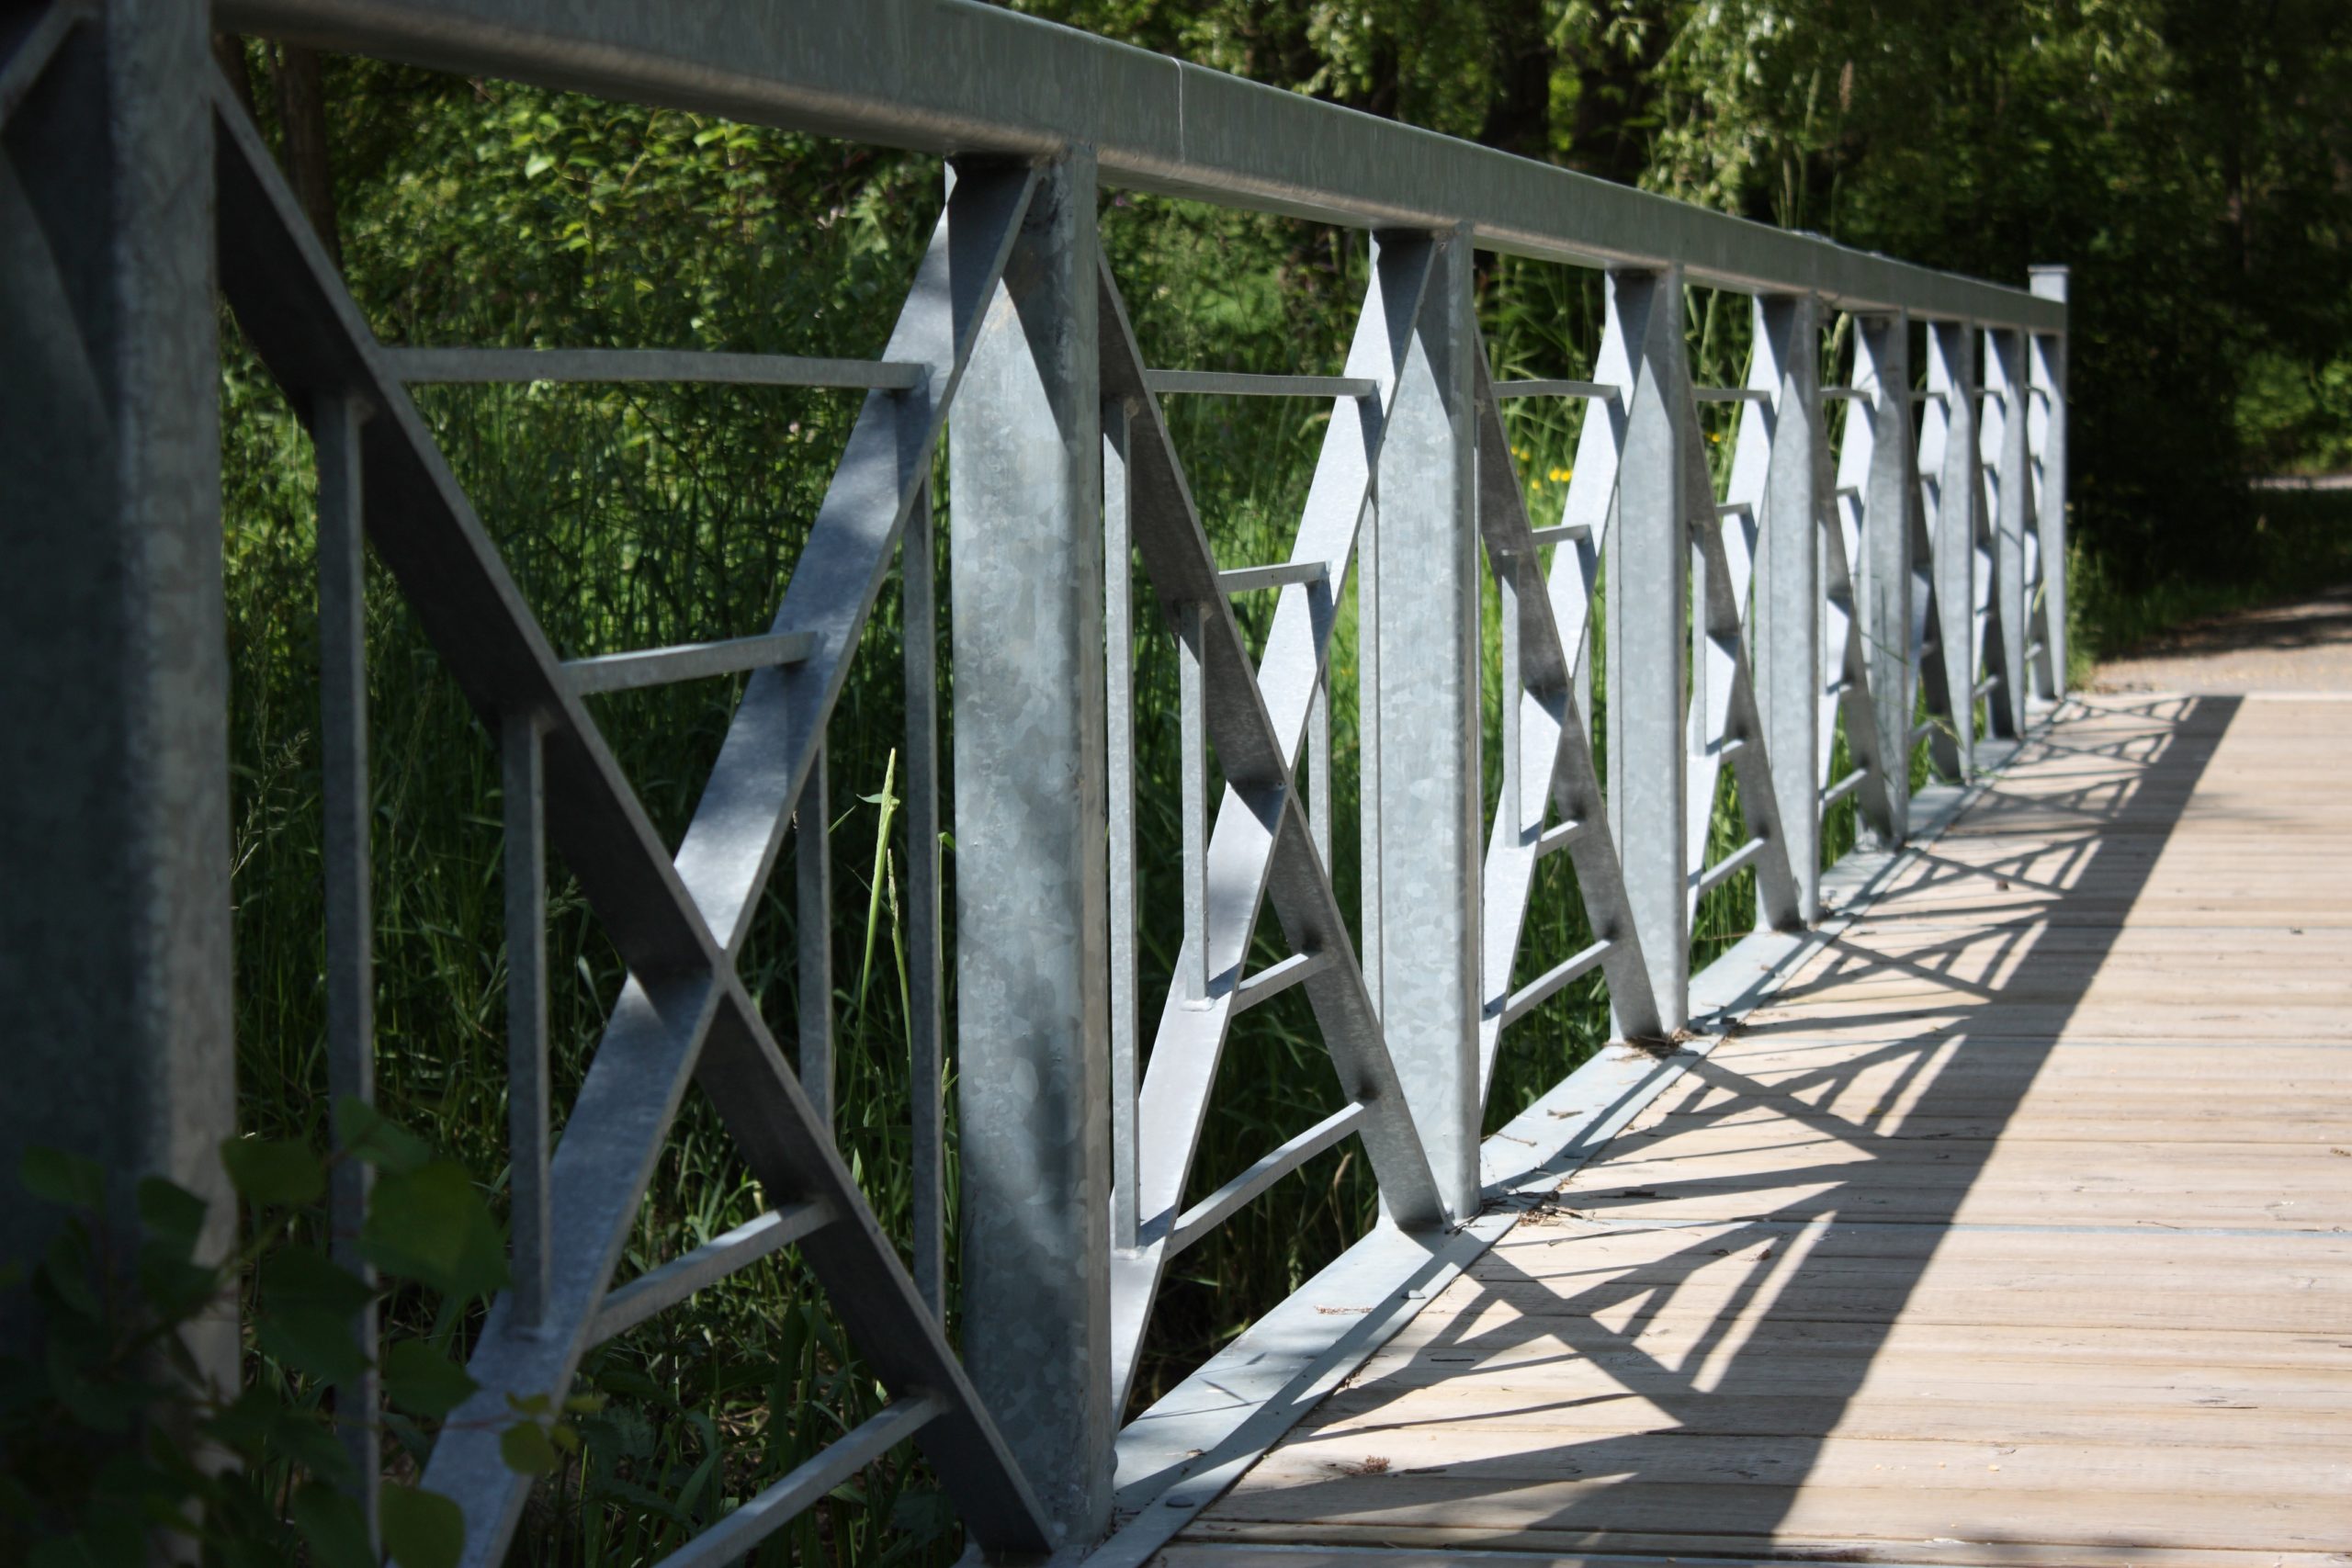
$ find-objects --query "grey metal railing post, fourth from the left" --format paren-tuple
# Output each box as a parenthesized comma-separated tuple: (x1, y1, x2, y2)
(1600, 268, 1691, 1034)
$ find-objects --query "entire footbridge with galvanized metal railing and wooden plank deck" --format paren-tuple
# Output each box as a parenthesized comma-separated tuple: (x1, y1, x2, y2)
(0, 0, 2352, 1568)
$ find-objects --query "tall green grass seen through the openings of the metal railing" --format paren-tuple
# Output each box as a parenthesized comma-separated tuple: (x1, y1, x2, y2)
(223, 63, 1966, 1563)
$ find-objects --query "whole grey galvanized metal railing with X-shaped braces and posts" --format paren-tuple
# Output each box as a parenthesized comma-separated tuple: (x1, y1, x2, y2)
(0, 0, 2065, 1563)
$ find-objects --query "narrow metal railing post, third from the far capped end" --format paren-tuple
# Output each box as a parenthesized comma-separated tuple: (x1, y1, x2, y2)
(1919, 322, 1985, 781)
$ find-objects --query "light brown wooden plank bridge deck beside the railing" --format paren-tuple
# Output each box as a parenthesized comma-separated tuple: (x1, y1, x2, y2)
(1162, 696, 2352, 1568)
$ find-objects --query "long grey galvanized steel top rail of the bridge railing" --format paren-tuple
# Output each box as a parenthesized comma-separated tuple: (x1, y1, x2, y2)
(214, 0, 2065, 332)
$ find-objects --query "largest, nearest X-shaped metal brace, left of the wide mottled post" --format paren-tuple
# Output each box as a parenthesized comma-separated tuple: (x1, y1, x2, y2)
(214, 80, 1051, 1568)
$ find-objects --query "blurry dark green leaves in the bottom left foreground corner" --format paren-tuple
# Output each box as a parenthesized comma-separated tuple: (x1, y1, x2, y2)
(0, 1105, 507, 1568)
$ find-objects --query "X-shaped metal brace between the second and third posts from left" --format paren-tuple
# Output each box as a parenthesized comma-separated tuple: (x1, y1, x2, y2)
(1101, 237, 1446, 1404)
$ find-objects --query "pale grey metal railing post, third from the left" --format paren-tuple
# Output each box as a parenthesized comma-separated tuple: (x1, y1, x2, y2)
(1366, 232, 1484, 1218)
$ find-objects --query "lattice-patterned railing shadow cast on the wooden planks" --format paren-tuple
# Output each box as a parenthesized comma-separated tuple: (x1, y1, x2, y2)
(1232, 696, 2239, 1554)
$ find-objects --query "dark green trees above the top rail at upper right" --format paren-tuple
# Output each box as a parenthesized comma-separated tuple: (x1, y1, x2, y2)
(1016, 0, 2352, 597)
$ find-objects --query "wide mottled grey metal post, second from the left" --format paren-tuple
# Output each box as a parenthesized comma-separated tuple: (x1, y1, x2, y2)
(948, 151, 1114, 1544)
